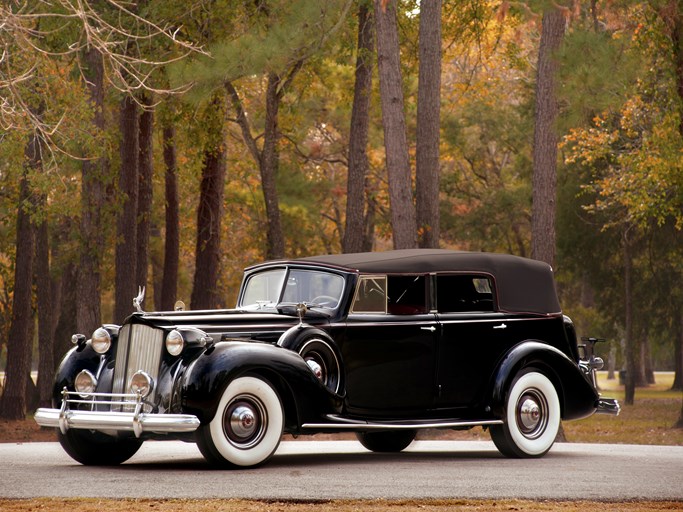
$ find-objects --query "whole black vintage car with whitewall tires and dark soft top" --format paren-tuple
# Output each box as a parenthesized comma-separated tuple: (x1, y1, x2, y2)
(35, 250, 619, 467)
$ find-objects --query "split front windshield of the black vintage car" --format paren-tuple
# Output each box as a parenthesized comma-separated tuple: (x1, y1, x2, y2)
(239, 268, 344, 309)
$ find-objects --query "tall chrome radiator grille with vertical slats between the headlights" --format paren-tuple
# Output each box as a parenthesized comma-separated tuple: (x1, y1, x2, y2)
(112, 324, 164, 412)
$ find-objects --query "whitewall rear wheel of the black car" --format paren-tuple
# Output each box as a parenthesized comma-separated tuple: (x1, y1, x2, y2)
(490, 371, 560, 458)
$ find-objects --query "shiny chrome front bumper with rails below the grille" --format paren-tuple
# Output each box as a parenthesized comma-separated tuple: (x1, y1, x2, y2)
(34, 390, 199, 437)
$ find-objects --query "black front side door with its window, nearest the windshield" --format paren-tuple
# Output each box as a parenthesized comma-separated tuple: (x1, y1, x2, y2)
(342, 275, 438, 418)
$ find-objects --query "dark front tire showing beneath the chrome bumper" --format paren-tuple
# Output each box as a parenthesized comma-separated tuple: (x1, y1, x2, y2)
(57, 429, 142, 466)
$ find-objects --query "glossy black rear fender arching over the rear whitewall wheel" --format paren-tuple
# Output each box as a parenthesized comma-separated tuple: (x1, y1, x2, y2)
(489, 340, 599, 420)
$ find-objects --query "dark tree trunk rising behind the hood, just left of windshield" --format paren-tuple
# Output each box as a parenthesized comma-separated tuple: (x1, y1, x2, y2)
(191, 93, 226, 309)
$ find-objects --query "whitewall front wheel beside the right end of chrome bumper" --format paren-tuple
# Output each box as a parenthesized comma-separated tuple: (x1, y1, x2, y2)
(197, 377, 284, 467)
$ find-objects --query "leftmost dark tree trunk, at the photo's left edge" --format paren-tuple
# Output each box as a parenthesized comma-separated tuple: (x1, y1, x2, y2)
(0, 142, 41, 420)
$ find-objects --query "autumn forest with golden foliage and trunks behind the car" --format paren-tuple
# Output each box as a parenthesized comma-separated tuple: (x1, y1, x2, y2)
(0, 0, 683, 425)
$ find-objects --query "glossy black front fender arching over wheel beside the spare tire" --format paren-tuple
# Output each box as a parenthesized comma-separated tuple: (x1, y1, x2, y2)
(181, 341, 338, 430)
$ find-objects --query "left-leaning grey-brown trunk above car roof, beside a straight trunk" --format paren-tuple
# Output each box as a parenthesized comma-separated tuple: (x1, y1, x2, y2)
(375, 0, 417, 249)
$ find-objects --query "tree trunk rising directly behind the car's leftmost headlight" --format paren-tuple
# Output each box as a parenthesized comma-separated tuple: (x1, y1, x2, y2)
(76, 49, 109, 336)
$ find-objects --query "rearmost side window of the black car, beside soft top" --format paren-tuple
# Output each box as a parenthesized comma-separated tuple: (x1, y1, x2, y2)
(436, 274, 494, 313)
